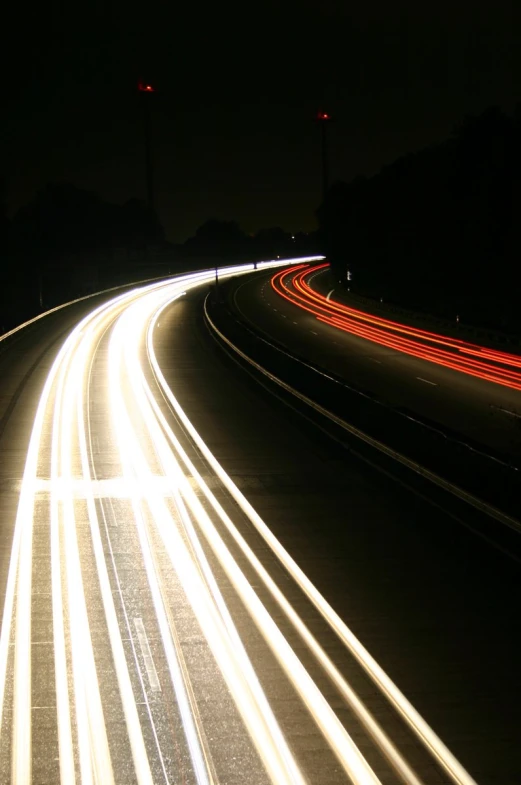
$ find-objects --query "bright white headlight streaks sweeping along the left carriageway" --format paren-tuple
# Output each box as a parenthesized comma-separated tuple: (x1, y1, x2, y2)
(0, 259, 474, 785)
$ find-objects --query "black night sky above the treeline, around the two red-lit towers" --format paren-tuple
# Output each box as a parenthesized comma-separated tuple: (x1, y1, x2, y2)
(0, 0, 521, 240)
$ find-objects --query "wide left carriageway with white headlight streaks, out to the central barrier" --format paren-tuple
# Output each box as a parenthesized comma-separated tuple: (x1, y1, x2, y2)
(0, 265, 521, 785)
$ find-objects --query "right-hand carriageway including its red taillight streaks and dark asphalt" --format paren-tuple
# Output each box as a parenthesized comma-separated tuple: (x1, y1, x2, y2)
(230, 267, 521, 462)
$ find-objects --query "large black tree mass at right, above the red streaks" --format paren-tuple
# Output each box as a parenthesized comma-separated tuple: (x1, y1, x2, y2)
(318, 108, 521, 332)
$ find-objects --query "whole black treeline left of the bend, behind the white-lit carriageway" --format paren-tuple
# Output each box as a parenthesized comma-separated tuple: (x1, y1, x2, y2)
(0, 183, 317, 332)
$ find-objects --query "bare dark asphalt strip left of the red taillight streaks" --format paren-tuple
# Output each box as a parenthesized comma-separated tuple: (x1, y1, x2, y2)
(230, 271, 521, 463)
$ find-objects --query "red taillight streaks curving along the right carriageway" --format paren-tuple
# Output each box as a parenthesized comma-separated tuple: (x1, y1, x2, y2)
(271, 264, 521, 390)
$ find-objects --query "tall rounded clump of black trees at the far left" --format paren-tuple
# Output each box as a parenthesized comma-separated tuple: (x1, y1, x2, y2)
(0, 183, 164, 328)
